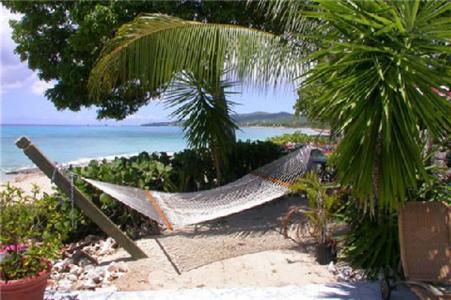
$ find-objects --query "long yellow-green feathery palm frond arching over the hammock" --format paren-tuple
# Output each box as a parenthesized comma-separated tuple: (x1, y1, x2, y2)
(88, 14, 299, 99)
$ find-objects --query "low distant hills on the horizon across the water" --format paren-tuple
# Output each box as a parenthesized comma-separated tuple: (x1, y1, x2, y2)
(141, 111, 317, 127)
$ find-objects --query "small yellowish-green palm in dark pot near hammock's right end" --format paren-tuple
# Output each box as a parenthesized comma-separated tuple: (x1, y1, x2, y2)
(283, 172, 338, 265)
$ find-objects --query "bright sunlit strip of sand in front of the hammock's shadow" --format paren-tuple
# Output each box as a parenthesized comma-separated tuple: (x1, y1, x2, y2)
(114, 250, 335, 291)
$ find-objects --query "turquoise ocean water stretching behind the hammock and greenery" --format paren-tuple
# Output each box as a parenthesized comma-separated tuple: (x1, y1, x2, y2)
(0, 125, 315, 175)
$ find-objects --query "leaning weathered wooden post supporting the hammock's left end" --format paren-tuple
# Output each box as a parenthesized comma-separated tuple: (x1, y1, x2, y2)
(16, 136, 148, 259)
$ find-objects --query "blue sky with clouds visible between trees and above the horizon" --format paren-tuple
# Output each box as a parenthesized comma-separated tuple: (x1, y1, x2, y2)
(0, 5, 297, 126)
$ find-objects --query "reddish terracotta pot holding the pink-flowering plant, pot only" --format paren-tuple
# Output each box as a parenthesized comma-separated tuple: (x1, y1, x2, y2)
(0, 264, 51, 300)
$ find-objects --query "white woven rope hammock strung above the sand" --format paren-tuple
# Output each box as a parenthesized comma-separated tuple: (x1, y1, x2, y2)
(83, 146, 319, 230)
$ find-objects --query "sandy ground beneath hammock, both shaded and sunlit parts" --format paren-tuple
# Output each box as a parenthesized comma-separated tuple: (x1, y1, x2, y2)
(93, 197, 336, 291)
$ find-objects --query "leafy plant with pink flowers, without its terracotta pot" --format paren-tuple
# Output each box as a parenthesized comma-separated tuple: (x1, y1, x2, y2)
(0, 185, 64, 281)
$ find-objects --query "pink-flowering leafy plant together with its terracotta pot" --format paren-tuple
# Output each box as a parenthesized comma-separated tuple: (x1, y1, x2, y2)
(0, 185, 61, 300)
